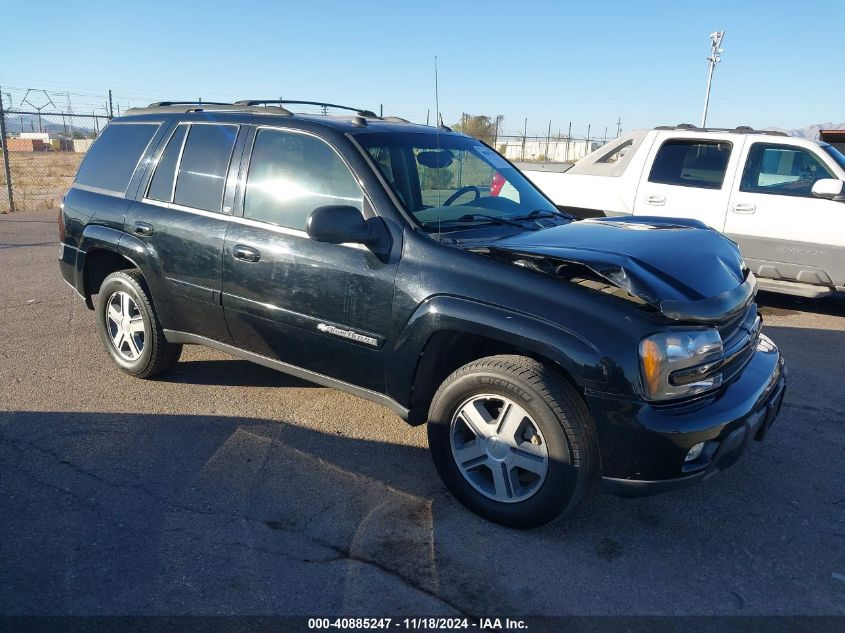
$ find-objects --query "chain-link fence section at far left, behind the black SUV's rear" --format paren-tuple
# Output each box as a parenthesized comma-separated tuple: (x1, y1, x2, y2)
(0, 108, 109, 213)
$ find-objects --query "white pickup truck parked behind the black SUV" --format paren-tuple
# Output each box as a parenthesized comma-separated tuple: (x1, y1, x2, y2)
(523, 125, 845, 297)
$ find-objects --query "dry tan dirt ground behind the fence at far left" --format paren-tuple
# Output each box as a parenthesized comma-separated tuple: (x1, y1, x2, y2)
(0, 151, 85, 213)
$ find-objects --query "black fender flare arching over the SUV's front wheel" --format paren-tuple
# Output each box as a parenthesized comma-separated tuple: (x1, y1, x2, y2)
(387, 295, 607, 404)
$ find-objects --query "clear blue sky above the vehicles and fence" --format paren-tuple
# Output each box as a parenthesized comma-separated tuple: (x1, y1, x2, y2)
(0, 0, 845, 136)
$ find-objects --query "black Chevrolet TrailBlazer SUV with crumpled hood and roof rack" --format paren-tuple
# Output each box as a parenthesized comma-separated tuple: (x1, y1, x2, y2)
(60, 101, 786, 527)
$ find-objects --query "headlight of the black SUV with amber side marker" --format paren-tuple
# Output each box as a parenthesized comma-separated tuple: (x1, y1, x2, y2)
(640, 329, 722, 400)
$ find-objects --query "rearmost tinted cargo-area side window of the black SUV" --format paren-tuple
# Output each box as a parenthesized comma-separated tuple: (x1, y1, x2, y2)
(76, 123, 160, 196)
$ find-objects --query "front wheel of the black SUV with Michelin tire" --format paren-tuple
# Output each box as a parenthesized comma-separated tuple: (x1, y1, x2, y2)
(428, 356, 598, 529)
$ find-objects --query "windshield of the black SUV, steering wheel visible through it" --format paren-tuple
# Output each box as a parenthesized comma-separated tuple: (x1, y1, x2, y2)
(356, 131, 557, 232)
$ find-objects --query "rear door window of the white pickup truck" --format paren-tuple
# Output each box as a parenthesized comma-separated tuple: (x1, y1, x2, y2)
(648, 139, 731, 189)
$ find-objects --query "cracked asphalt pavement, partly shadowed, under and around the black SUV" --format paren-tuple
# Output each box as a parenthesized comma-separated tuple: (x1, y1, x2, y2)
(0, 211, 845, 616)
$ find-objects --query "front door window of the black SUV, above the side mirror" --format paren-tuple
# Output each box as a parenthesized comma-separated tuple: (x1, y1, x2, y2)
(244, 129, 364, 230)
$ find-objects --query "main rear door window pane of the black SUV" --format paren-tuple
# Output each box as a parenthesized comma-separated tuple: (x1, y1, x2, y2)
(168, 124, 238, 212)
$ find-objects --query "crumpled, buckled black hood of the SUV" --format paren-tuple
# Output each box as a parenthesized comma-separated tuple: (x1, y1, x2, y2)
(490, 217, 756, 322)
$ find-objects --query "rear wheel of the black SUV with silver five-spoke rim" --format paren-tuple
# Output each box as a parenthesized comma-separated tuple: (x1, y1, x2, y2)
(95, 270, 182, 378)
